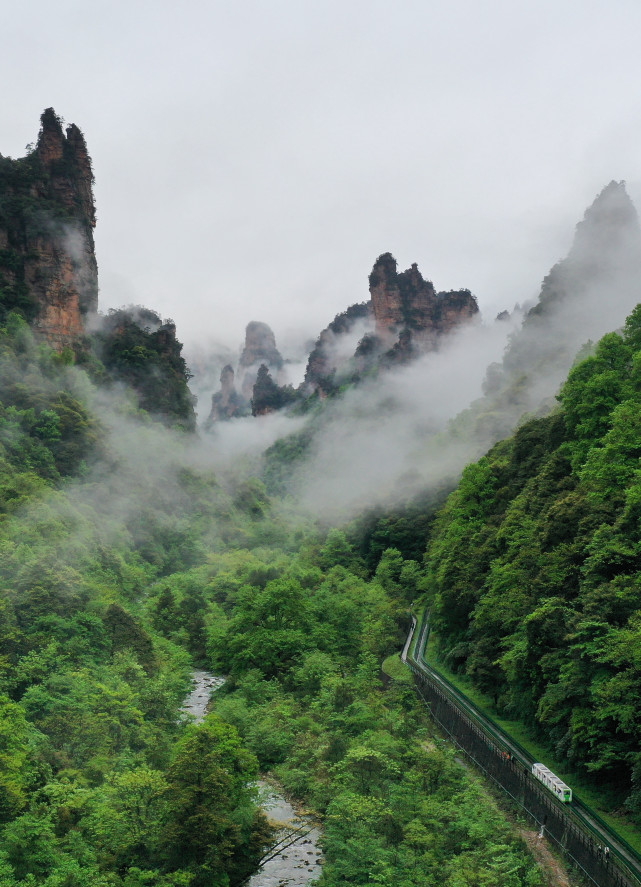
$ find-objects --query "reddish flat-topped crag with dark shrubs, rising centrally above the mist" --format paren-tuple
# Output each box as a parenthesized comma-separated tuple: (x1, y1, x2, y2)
(369, 253, 479, 353)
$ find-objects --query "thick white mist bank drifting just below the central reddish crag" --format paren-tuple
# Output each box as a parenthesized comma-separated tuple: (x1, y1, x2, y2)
(278, 314, 521, 522)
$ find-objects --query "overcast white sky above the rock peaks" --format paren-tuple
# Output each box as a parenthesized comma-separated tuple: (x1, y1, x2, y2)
(0, 0, 641, 351)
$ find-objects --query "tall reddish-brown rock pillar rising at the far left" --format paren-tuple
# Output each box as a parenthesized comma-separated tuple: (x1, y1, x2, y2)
(0, 108, 98, 349)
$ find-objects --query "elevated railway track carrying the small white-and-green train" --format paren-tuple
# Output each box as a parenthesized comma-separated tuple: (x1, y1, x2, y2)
(401, 611, 641, 887)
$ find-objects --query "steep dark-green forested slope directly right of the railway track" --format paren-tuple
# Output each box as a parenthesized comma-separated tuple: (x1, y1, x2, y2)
(427, 306, 641, 822)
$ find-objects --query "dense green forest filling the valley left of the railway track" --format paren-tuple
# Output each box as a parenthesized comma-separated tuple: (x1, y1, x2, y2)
(0, 313, 541, 887)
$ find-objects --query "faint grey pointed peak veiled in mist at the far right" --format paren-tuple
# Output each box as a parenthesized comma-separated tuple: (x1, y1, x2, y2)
(484, 181, 641, 439)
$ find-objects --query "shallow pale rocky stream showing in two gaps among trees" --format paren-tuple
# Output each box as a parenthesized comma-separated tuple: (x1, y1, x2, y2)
(181, 669, 322, 887)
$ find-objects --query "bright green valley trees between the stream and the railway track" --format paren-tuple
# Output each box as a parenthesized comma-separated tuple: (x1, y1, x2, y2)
(200, 530, 540, 887)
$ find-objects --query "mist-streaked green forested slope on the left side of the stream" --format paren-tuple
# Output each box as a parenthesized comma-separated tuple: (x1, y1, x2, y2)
(0, 315, 290, 887)
